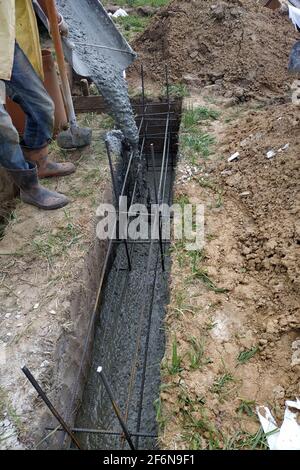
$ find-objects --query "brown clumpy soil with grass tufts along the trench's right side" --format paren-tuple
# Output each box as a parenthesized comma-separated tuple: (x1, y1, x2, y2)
(160, 88, 300, 449)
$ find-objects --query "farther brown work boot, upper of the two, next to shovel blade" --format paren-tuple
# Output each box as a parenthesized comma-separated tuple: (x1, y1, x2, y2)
(22, 145, 76, 179)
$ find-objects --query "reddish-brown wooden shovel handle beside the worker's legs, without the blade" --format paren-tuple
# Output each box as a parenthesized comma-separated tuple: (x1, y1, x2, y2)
(46, 0, 76, 128)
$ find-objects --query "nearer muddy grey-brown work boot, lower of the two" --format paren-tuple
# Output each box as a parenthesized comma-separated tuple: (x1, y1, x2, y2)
(7, 163, 69, 210)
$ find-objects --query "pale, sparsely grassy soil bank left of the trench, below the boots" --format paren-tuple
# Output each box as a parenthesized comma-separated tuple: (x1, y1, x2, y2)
(0, 115, 111, 449)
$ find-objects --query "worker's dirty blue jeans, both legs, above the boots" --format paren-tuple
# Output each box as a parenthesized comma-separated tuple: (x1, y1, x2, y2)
(0, 43, 54, 169)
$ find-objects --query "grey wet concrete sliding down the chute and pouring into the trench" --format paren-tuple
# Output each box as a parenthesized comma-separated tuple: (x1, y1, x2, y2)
(57, 0, 138, 149)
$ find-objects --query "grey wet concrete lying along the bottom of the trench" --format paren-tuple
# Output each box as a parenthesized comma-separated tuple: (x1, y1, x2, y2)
(76, 157, 172, 449)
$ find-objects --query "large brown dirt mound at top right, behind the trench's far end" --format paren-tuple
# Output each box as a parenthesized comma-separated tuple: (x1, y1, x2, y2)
(134, 0, 296, 101)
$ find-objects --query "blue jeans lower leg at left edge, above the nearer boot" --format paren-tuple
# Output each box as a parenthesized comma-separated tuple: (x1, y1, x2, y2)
(0, 103, 28, 170)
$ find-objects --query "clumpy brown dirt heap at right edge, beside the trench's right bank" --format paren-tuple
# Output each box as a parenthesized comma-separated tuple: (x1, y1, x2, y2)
(223, 104, 300, 298)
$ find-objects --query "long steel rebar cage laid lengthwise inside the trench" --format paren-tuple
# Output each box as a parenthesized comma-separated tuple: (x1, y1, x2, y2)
(56, 64, 177, 447)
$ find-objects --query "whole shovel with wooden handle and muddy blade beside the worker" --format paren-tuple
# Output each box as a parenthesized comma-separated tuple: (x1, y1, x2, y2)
(47, 0, 92, 149)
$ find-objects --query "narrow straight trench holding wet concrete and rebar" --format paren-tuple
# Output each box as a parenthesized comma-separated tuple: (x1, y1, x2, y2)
(76, 101, 181, 450)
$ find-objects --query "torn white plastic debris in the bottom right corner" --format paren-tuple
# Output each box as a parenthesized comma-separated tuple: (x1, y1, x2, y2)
(256, 399, 300, 450)
